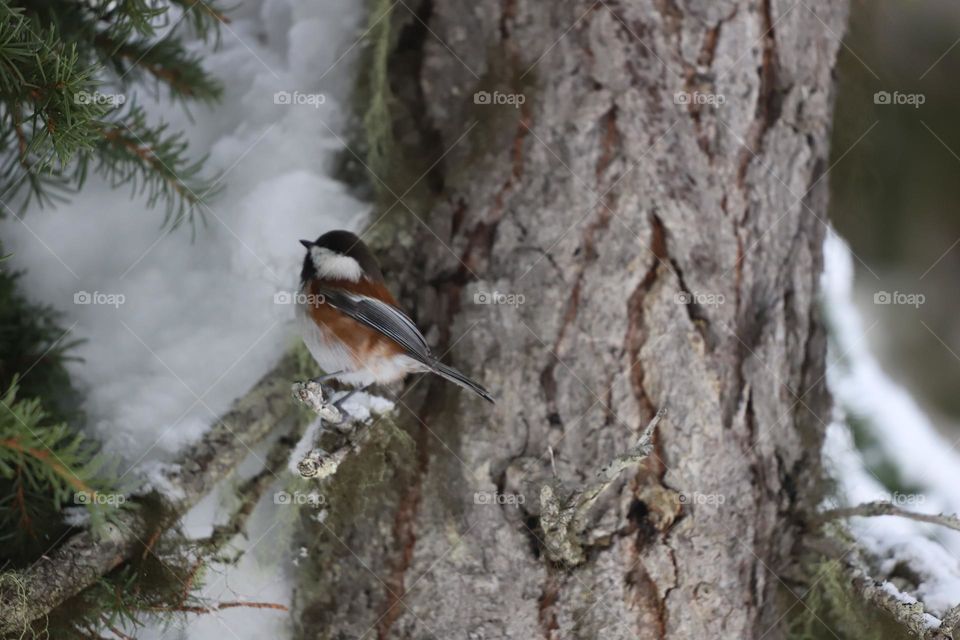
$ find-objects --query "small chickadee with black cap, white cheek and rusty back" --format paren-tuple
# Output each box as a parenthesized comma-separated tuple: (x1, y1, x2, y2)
(297, 231, 494, 402)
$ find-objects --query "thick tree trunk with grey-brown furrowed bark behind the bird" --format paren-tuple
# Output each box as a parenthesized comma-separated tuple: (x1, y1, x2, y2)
(296, 0, 846, 639)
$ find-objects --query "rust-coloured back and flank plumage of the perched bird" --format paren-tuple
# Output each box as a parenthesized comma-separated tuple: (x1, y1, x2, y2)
(310, 278, 403, 368)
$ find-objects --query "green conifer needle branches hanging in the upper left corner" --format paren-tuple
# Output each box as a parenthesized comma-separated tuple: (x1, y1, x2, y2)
(0, 0, 225, 226)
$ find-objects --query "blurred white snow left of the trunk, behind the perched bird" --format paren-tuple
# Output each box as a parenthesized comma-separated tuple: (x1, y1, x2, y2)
(0, 0, 368, 640)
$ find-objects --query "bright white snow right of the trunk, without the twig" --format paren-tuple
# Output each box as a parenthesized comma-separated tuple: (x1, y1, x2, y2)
(822, 234, 960, 614)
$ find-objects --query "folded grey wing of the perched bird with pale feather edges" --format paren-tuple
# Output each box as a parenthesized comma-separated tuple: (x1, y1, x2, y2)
(316, 287, 434, 366)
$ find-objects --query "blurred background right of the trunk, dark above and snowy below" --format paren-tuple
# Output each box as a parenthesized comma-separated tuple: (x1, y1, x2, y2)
(823, 0, 960, 613)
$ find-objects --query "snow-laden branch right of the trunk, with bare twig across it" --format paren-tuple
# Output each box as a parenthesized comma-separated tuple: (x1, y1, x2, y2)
(818, 234, 960, 637)
